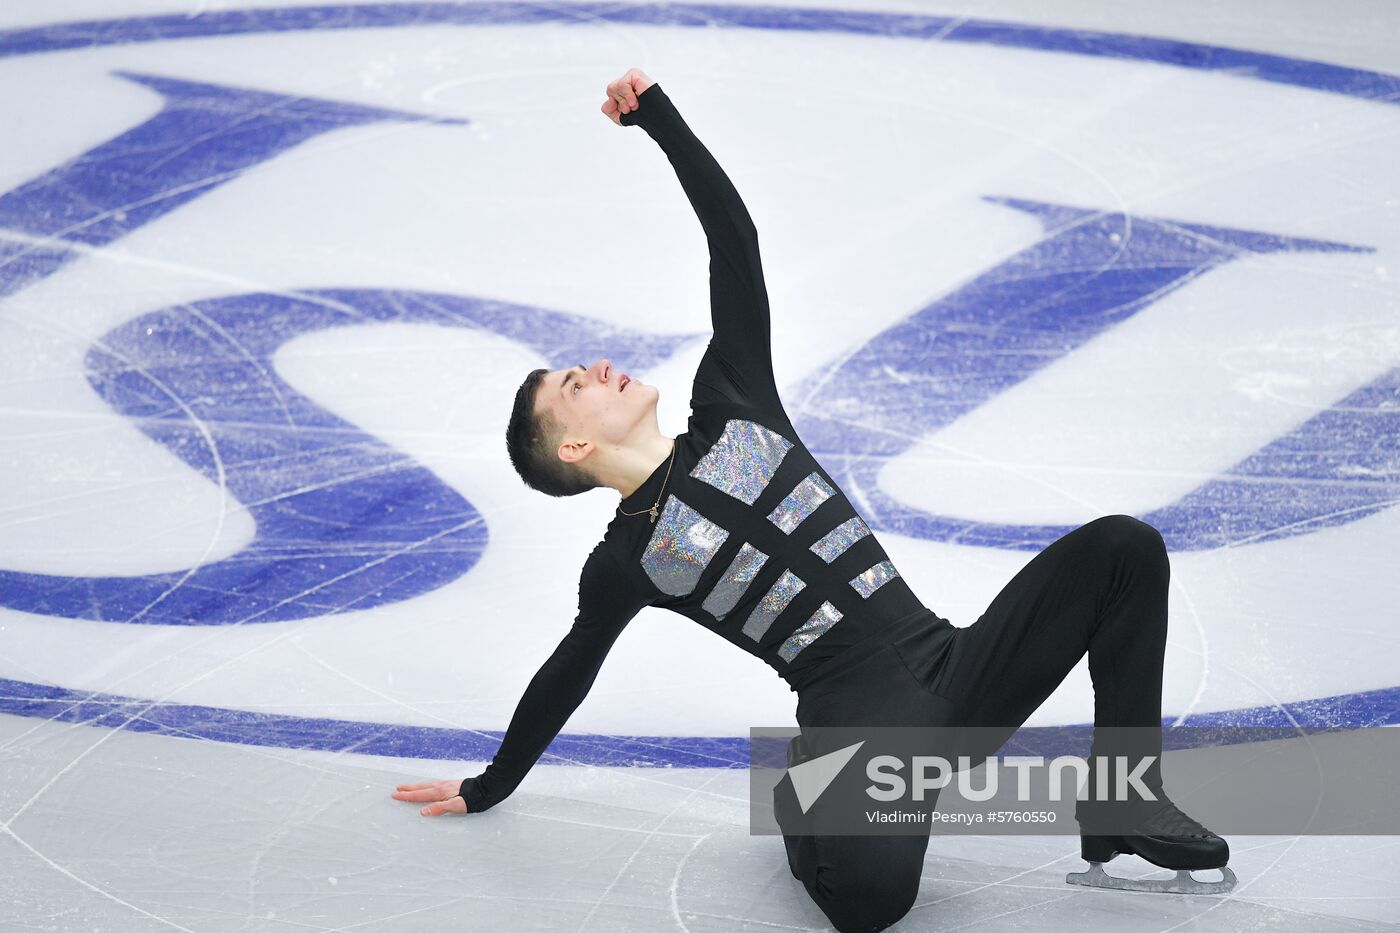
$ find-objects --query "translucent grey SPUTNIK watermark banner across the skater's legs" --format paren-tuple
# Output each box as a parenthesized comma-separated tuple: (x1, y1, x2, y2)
(749, 726, 1400, 836)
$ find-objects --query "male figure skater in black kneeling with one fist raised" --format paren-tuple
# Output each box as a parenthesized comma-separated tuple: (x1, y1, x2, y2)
(393, 69, 1229, 932)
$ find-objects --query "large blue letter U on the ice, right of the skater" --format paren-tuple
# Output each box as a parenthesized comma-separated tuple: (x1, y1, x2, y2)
(791, 198, 1383, 552)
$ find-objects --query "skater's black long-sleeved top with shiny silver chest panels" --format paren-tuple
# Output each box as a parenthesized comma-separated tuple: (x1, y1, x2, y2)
(462, 84, 937, 811)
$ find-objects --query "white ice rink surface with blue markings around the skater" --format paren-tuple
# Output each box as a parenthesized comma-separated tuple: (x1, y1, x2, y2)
(0, 0, 1400, 933)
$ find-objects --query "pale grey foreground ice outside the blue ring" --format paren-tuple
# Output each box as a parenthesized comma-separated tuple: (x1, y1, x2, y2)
(0, 708, 1400, 933)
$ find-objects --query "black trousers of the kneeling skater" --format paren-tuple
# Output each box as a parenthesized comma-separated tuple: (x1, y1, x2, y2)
(776, 516, 1170, 933)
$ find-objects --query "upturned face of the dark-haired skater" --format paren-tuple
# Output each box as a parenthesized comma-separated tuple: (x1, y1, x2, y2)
(535, 360, 661, 464)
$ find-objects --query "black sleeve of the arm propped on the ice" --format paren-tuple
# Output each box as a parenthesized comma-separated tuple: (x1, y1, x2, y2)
(458, 544, 645, 813)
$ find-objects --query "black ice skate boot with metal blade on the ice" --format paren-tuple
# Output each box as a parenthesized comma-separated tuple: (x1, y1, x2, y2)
(1065, 792, 1235, 894)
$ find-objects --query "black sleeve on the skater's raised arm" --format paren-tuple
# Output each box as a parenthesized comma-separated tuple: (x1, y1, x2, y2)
(619, 84, 783, 412)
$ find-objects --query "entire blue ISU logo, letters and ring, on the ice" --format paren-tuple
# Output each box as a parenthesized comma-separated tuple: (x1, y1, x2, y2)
(0, 3, 1400, 761)
